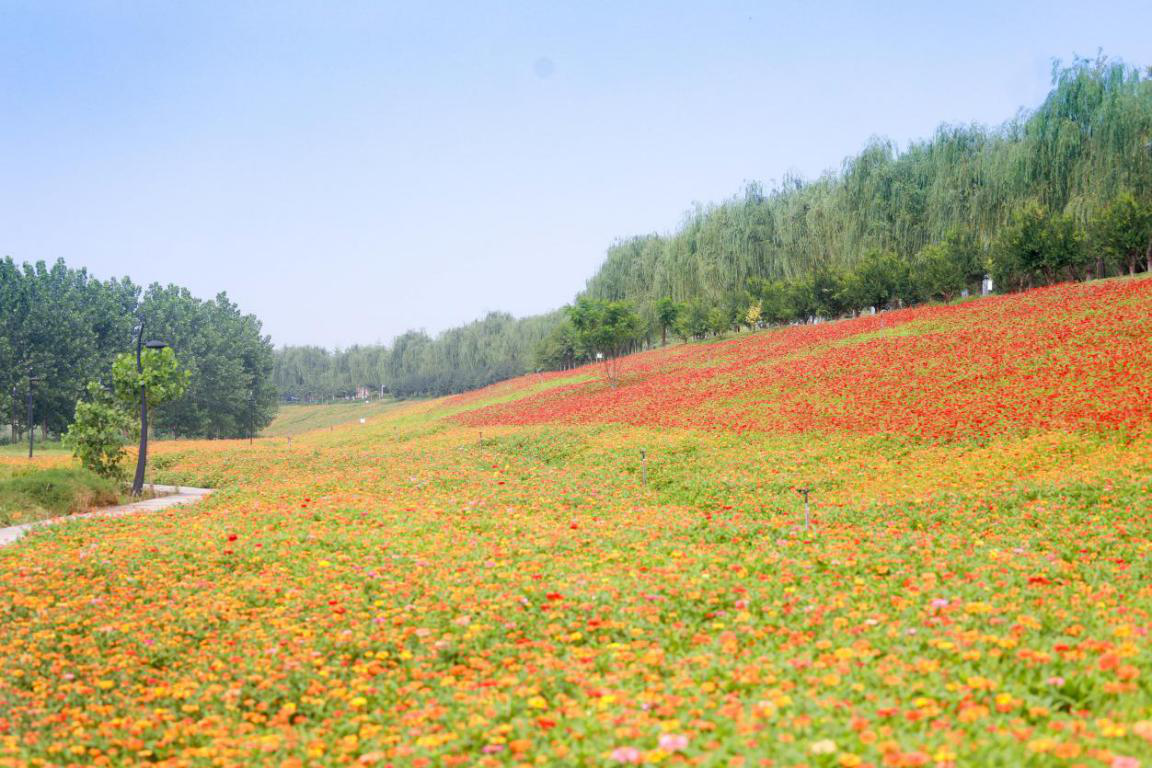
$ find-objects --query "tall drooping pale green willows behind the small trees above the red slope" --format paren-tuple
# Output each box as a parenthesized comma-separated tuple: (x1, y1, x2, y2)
(586, 59, 1152, 322)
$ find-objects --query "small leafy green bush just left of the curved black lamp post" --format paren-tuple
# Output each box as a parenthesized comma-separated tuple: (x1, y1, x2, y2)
(63, 381, 138, 480)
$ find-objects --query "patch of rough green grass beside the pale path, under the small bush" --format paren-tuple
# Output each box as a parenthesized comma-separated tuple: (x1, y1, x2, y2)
(0, 469, 120, 526)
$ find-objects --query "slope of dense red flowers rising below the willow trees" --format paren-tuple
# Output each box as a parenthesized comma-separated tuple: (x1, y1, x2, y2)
(449, 279, 1152, 440)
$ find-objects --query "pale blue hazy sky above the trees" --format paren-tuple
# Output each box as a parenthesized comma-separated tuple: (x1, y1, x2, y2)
(0, 0, 1152, 345)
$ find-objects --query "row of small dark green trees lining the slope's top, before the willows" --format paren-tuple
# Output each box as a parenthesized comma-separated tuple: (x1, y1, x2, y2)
(537, 187, 1152, 368)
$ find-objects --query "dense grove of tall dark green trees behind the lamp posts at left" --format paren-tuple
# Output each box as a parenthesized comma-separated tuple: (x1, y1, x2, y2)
(0, 258, 276, 438)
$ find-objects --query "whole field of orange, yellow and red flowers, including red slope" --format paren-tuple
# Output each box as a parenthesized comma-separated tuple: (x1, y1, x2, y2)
(0, 279, 1152, 768)
